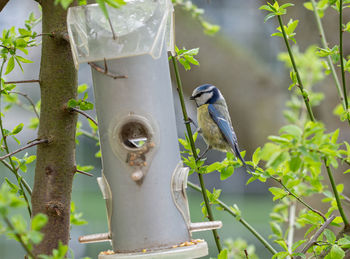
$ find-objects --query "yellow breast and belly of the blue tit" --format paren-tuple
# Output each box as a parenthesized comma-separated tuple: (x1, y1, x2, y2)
(197, 104, 229, 151)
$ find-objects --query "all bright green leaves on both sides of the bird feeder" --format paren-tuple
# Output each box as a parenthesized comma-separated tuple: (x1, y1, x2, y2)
(0, 0, 350, 259)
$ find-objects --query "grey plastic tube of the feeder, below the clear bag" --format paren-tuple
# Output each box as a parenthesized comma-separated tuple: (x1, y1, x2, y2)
(92, 46, 190, 252)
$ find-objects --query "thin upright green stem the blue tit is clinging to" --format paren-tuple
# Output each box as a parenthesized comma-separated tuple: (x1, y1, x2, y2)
(171, 56, 222, 253)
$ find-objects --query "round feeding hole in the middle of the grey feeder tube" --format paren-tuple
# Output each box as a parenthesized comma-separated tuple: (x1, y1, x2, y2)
(120, 121, 149, 149)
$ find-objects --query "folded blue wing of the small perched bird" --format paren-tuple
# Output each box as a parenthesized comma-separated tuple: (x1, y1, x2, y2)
(208, 104, 246, 166)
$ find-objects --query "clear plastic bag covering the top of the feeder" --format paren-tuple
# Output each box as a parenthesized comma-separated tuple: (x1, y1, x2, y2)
(67, 0, 174, 67)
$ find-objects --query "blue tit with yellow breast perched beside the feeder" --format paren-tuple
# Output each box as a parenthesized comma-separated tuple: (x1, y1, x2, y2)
(190, 84, 249, 170)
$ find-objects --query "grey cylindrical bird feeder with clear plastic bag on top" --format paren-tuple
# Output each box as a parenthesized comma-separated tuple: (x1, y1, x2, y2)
(68, 0, 221, 259)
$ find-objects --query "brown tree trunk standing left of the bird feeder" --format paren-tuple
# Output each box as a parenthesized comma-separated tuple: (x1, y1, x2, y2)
(32, 0, 77, 255)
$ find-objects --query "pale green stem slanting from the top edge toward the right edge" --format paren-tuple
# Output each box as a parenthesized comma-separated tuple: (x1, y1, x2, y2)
(311, 0, 350, 123)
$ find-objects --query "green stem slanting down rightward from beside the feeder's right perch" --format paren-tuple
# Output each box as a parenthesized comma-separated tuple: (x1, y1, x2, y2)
(187, 182, 277, 255)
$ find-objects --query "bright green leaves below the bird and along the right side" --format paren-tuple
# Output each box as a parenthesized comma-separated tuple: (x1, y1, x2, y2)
(179, 0, 350, 259)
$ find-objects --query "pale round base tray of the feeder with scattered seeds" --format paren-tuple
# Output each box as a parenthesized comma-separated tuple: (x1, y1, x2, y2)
(98, 241, 208, 259)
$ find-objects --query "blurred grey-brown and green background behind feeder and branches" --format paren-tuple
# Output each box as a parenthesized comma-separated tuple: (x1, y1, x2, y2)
(0, 0, 350, 259)
